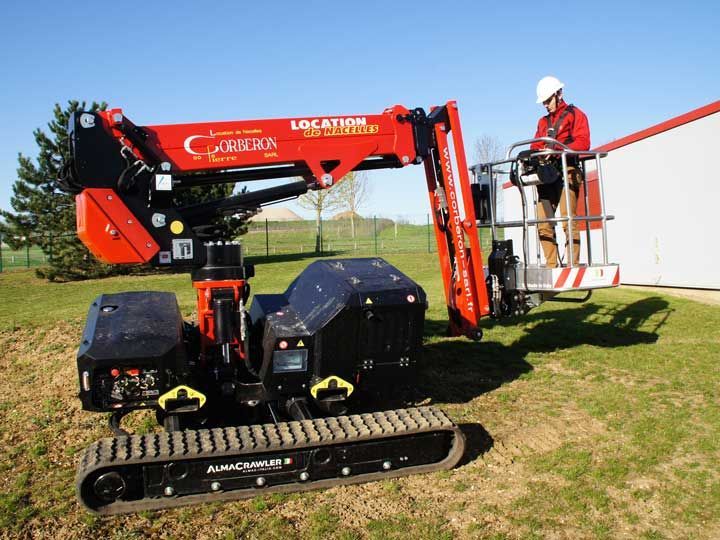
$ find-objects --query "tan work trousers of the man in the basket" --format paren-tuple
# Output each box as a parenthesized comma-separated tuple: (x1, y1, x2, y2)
(537, 167, 582, 268)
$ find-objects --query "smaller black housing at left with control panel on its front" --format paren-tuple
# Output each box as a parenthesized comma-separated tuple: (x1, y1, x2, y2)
(77, 292, 187, 411)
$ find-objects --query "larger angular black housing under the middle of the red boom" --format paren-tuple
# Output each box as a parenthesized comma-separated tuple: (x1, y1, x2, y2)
(250, 258, 427, 393)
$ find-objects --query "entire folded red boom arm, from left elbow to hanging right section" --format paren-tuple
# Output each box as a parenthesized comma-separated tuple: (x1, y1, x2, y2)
(70, 101, 490, 337)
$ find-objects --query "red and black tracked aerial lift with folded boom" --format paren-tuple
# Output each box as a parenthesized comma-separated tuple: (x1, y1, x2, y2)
(61, 101, 613, 514)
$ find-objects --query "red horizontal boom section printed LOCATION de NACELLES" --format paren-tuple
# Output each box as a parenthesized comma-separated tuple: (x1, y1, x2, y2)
(101, 105, 415, 187)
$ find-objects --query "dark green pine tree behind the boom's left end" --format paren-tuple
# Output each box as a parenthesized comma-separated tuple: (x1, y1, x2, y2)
(0, 101, 119, 280)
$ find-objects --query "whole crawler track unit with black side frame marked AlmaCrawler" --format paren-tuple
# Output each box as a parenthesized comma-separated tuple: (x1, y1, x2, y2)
(77, 407, 465, 515)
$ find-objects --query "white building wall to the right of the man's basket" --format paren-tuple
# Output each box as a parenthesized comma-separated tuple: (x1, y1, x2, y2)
(603, 113, 720, 289)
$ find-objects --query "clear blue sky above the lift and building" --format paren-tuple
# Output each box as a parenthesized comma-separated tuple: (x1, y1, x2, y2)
(0, 0, 720, 219)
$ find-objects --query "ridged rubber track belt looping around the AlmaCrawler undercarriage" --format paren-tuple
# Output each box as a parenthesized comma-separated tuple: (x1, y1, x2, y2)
(76, 407, 465, 515)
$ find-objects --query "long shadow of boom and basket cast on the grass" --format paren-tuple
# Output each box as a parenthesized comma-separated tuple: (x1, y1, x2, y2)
(416, 297, 671, 403)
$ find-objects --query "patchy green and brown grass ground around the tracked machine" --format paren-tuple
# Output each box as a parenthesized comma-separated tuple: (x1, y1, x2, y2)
(0, 254, 720, 540)
